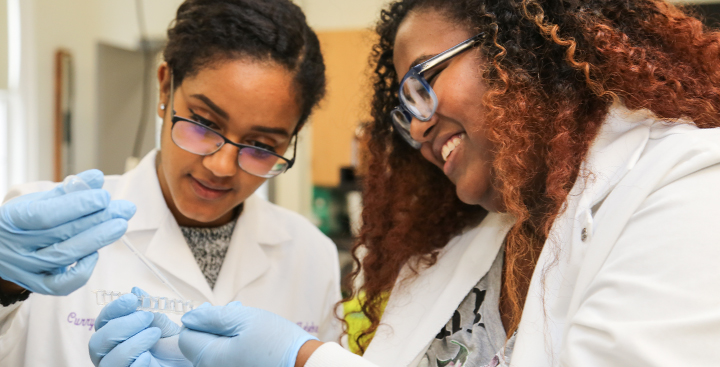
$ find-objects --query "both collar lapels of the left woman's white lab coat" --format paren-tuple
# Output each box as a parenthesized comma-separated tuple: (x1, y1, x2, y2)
(113, 151, 292, 304)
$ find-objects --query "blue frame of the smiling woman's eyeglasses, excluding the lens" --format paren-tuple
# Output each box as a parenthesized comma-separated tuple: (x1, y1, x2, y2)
(390, 32, 486, 149)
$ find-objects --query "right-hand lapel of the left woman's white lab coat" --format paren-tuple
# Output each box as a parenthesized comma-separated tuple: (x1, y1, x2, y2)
(214, 195, 291, 304)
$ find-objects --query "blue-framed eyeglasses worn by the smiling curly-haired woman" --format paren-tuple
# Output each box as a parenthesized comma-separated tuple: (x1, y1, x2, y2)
(390, 32, 485, 149)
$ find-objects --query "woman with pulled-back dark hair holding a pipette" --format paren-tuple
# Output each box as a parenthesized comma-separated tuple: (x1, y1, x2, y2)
(0, 0, 341, 367)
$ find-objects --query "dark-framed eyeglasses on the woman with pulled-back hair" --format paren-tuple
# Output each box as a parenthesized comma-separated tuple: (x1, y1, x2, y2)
(169, 75, 297, 178)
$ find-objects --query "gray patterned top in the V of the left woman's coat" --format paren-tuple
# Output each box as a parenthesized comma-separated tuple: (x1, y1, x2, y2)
(180, 220, 236, 288)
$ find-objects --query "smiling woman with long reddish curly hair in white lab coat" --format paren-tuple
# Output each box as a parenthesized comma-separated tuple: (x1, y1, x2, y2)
(155, 0, 720, 367)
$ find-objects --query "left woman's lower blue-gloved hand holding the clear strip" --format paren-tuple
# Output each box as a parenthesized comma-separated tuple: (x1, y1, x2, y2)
(89, 287, 192, 367)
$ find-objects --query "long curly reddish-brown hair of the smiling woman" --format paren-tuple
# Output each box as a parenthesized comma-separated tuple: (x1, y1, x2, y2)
(349, 0, 720, 350)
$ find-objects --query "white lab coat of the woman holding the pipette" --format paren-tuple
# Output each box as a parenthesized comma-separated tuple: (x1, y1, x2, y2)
(0, 152, 341, 367)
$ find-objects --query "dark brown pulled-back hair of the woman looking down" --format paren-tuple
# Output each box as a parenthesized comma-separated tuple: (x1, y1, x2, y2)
(163, 0, 325, 130)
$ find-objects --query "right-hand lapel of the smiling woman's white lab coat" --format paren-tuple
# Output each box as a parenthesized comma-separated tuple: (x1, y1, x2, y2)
(511, 105, 655, 366)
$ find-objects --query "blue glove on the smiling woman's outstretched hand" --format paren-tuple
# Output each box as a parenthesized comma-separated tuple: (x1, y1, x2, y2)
(180, 302, 317, 367)
